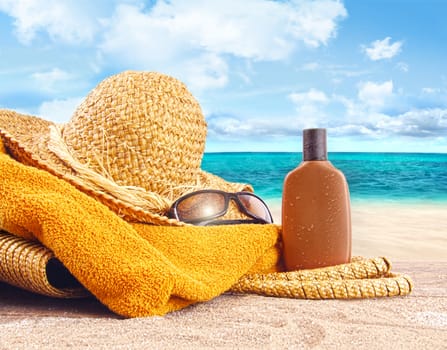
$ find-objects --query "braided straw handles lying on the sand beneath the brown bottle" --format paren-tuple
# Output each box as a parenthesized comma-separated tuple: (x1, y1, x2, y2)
(231, 257, 413, 299)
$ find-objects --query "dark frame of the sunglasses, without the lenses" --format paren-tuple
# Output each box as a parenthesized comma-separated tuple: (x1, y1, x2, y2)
(168, 190, 273, 226)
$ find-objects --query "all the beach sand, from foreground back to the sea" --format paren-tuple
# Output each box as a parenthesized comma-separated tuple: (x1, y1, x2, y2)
(0, 203, 447, 350)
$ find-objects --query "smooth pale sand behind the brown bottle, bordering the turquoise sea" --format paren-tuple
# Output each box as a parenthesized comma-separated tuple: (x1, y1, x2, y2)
(267, 200, 447, 261)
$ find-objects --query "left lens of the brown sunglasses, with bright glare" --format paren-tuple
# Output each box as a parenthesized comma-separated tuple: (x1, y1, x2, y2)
(177, 192, 225, 222)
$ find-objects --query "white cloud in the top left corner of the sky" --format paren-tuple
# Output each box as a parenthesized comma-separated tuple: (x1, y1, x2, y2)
(0, 0, 102, 44)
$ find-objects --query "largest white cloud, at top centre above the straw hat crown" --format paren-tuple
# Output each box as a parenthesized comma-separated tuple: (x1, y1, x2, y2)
(99, 0, 346, 88)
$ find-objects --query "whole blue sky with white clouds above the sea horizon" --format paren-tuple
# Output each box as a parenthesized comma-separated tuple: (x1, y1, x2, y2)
(0, 0, 447, 153)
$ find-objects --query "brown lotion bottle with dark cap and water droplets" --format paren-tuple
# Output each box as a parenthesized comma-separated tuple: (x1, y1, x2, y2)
(282, 129, 351, 271)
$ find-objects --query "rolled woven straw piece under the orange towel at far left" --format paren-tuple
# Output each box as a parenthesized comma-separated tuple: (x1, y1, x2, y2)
(0, 231, 88, 298)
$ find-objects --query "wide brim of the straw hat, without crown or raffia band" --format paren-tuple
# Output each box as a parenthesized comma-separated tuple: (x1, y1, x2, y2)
(0, 110, 253, 226)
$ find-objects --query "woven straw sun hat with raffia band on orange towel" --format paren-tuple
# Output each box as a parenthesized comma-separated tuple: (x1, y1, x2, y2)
(0, 71, 253, 225)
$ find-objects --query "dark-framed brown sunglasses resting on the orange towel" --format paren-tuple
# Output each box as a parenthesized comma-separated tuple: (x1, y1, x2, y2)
(168, 190, 273, 226)
